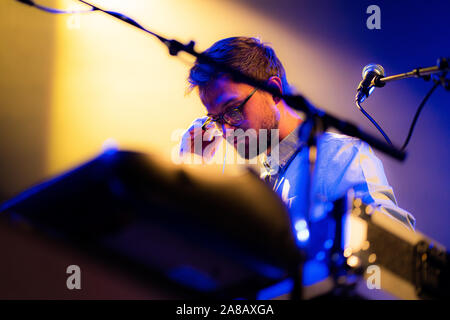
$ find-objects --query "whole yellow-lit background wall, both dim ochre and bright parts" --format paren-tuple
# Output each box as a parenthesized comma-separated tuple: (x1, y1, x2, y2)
(0, 0, 344, 196)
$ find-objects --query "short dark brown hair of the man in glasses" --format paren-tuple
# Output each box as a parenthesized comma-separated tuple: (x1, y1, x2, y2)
(188, 37, 290, 93)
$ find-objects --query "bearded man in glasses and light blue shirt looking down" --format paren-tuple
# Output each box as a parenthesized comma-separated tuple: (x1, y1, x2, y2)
(181, 37, 415, 229)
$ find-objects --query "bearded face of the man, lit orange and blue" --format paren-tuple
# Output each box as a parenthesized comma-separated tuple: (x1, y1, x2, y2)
(200, 76, 280, 159)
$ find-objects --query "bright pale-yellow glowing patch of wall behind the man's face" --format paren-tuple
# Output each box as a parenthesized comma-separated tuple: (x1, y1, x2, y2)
(47, 0, 316, 173)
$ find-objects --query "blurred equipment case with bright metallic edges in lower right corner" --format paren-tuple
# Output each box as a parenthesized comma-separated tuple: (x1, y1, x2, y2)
(322, 191, 450, 300)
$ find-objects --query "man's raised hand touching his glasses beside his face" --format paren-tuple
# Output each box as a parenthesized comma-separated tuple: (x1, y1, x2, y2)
(180, 117, 222, 161)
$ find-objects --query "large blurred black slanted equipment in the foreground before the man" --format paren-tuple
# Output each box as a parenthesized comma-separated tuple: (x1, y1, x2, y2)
(0, 150, 299, 298)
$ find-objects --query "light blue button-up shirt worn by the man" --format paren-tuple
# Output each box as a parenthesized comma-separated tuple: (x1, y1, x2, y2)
(261, 127, 415, 229)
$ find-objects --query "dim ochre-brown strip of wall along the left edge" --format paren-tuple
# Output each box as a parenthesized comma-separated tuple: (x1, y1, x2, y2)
(0, 0, 56, 200)
